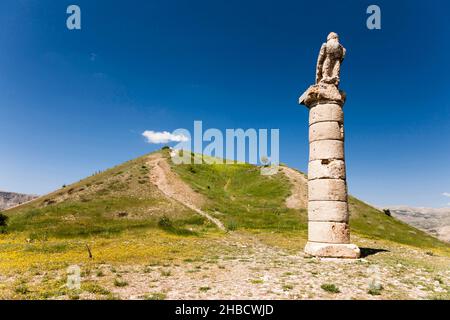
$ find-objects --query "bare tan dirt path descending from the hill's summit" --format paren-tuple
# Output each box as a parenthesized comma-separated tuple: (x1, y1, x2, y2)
(148, 154, 226, 231)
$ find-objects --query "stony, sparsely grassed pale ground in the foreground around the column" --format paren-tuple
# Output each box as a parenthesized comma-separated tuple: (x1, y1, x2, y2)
(0, 232, 450, 300)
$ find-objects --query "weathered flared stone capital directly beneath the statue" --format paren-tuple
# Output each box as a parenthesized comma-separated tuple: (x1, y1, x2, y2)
(298, 82, 346, 109)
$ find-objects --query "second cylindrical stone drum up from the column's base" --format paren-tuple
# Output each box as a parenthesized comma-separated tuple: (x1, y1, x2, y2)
(308, 201, 348, 222)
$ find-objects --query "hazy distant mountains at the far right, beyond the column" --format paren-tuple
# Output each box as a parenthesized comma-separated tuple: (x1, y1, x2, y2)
(388, 206, 450, 242)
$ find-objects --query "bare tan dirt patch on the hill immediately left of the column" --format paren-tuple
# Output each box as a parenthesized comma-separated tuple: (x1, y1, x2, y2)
(280, 166, 308, 209)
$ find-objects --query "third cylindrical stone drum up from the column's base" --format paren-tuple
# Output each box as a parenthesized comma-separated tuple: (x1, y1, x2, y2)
(308, 179, 347, 201)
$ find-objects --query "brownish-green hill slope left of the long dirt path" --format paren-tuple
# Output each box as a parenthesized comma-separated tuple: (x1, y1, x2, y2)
(2, 156, 209, 239)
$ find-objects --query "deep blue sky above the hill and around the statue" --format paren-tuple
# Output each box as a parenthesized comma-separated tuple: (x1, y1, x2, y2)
(0, 0, 450, 207)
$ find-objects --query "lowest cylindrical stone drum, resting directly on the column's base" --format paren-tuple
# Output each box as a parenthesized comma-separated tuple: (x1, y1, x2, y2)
(308, 221, 350, 243)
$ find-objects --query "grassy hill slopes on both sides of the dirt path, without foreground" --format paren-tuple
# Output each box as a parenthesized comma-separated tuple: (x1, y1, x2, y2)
(2, 150, 448, 248)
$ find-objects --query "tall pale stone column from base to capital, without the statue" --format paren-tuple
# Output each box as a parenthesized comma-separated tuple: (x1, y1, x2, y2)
(299, 83, 360, 258)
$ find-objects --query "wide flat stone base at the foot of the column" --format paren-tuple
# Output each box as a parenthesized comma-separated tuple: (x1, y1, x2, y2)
(305, 241, 361, 259)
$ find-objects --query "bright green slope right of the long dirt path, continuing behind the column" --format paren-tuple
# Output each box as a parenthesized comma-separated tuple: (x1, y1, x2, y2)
(168, 150, 448, 248)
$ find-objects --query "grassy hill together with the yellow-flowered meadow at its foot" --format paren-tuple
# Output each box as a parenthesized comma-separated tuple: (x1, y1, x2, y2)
(0, 149, 450, 298)
